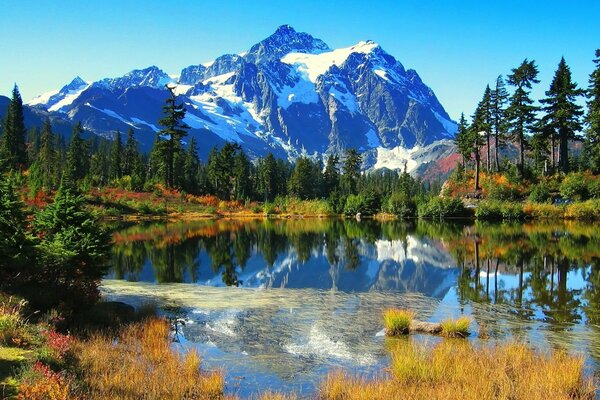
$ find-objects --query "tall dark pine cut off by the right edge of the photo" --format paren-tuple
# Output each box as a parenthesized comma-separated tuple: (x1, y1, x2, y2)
(586, 49, 600, 174)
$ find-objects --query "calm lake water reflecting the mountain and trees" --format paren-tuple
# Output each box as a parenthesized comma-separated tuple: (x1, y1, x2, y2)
(102, 219, 600, 397)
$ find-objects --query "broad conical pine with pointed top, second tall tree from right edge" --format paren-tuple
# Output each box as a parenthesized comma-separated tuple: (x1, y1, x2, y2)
(540, 57, 584, 173)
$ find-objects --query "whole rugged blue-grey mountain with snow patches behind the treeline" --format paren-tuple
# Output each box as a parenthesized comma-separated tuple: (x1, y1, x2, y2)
(22, 25, 456, 173)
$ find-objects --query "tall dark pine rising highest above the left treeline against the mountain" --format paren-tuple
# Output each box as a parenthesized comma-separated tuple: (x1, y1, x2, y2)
(158, 86, 190, 188)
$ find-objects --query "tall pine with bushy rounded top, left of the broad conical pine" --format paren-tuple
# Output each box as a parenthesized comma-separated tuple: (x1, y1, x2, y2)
(507, 59, 539, 176)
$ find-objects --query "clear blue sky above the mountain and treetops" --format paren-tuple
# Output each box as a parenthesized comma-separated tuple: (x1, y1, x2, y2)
(0, 0, 600, 119)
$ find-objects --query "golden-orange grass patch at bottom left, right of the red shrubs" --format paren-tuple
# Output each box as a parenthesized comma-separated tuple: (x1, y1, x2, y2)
(75, 318, 223, 400)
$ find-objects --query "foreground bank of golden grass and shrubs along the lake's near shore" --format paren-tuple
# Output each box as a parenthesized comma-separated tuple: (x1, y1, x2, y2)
(0, 299, 595, 400)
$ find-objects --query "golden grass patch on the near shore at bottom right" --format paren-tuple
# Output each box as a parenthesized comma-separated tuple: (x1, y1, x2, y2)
(320, 341, 595, 400)
